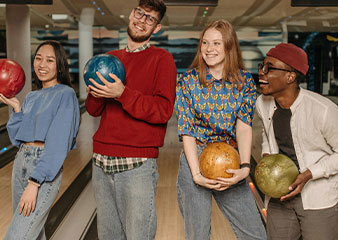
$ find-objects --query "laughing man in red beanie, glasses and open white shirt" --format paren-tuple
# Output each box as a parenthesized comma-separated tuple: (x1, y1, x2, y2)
(256, 43, 338, 240)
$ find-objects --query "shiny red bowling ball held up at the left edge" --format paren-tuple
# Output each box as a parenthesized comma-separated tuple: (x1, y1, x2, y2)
(0, 59, 26, 98)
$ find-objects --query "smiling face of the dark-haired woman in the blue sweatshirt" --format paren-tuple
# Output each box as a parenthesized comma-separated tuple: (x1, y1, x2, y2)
(33, 45, 58, 88)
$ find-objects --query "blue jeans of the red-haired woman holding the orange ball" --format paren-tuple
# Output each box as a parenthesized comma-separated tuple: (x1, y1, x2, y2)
(177, 146, 266, 240)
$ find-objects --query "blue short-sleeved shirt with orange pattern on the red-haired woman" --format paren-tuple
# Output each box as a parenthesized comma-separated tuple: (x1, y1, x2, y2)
(175, 66, 257, 142)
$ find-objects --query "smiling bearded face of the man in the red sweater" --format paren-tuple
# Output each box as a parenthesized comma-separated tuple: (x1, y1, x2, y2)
(127, 7, 161, 43)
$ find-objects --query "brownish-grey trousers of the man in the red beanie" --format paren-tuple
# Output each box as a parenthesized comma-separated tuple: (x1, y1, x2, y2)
(267, 194, 338, 240)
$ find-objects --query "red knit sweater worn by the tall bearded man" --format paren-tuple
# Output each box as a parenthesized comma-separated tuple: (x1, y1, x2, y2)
(86, 46, 176, 158)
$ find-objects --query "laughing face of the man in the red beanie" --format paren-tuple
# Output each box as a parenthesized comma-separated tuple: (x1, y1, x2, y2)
(258, 56, 296, 98)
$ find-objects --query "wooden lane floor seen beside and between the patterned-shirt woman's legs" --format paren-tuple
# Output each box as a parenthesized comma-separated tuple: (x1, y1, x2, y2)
(155, 114, 236, 240)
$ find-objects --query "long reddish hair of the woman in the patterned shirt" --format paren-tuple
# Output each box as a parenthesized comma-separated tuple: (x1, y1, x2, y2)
(190, 19, 244, 89)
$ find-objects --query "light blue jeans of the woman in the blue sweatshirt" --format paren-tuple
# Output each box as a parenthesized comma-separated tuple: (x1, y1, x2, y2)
(5, 144, 62, 240)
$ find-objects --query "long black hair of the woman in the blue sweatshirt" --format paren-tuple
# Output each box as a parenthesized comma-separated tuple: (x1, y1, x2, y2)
(33, 40, 71, 89)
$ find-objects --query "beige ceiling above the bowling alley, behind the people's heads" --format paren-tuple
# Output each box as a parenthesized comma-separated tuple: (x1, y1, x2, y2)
(0, 0, 338, 32)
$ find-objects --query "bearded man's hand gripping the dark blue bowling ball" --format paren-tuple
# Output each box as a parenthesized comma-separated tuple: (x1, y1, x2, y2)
(88, 72, 124, 98)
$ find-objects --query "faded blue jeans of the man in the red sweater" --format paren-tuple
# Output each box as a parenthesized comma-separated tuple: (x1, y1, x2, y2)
(92, 159, 158, 240)
